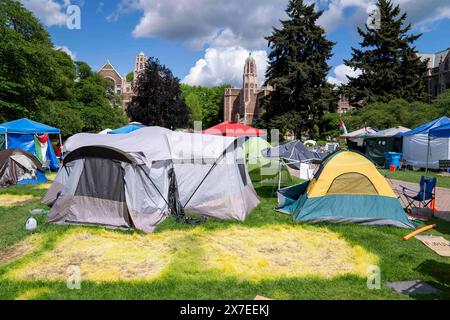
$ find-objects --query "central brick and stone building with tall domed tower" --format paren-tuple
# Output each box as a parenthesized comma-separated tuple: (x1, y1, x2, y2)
(224, 54, 273, 125)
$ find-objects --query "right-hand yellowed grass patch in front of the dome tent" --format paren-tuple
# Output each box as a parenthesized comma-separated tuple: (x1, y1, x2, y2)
(200, 226, 377, 281)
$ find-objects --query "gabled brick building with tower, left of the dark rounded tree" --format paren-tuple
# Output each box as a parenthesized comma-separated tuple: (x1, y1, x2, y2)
(99, 52, 147, 109)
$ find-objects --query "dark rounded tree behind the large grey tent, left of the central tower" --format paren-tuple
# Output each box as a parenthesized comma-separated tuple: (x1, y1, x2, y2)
(127, 57, 190, 129)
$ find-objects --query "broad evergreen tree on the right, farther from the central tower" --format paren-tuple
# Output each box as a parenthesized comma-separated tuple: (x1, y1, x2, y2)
(343, 0, 426, 106)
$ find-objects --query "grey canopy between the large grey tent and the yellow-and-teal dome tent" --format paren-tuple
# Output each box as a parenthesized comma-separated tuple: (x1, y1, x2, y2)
(262, 140, 327, 169)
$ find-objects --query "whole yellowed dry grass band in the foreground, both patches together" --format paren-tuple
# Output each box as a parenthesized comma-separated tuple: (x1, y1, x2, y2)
(5, 225, 377, 282)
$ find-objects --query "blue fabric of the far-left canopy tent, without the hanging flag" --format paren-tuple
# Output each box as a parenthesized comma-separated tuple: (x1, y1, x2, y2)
(0, 118, 62, 171)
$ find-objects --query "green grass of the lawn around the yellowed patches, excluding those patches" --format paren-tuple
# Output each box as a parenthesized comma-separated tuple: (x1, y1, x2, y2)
(0, 176, 450, 299)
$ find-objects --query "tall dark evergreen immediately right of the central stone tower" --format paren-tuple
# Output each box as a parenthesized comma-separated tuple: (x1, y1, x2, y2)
(262, 0, 336, 137)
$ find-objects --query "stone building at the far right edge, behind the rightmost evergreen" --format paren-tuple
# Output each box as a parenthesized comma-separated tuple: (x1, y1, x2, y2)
(419, 48, 450, 101)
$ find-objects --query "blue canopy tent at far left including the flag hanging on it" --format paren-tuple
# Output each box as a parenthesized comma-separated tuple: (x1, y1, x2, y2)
(0, 118, 61, 171)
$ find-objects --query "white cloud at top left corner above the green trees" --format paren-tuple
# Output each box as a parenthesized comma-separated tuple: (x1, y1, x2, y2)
(21, 0, 70, 26)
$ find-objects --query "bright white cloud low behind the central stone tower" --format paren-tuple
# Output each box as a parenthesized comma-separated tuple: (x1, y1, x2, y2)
(183, 46, 267, 87)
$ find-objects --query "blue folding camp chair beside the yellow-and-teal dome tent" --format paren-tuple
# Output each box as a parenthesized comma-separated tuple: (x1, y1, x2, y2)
(400, 176, 436, 214)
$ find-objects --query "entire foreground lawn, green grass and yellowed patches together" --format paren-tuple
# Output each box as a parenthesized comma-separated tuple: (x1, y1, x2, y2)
(0, 173, 450, 299)
